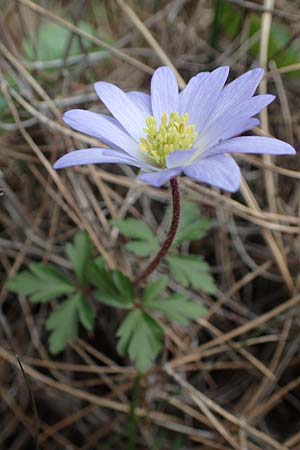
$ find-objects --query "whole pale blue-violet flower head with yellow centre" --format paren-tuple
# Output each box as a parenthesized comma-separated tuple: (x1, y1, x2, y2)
(54, 67, 295, 192)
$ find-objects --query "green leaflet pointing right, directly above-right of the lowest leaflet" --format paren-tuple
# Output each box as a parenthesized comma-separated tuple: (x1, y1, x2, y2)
(147, 294, 207, 325)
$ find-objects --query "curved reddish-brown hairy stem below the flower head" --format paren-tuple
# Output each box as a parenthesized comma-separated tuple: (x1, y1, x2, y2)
(134, 177, 180, 284)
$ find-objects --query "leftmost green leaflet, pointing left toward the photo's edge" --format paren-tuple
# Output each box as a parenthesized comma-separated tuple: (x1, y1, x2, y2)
(6, 263, 76, 303)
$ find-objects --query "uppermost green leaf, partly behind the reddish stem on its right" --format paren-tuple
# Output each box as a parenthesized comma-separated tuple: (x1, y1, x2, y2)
(167, 201, 211, 246)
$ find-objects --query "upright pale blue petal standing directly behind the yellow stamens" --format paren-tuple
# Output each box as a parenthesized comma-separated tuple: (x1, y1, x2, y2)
(151, 67, 179, 125)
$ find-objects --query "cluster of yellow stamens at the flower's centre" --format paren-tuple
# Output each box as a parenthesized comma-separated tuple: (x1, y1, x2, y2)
(140, 112, 198, 167)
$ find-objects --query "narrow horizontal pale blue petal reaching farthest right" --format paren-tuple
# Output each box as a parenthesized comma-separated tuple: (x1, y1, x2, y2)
(205, 136, 296, 157)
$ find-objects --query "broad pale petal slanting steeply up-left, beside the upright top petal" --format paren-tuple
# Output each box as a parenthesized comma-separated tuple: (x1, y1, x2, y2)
(95, 81, 147, 142)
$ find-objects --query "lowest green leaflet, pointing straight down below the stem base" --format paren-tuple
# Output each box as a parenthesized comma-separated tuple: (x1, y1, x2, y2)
(117, 309, 163, 372)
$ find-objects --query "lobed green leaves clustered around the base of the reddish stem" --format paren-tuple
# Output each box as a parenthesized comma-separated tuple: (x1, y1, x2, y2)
(7, 203, 215, 371)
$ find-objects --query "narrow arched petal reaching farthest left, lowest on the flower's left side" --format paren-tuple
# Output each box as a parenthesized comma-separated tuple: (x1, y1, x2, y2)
(53, 148, 144, 169)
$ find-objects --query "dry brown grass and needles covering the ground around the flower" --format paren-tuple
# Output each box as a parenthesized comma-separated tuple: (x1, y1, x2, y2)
(0, 0, 300, 450)
